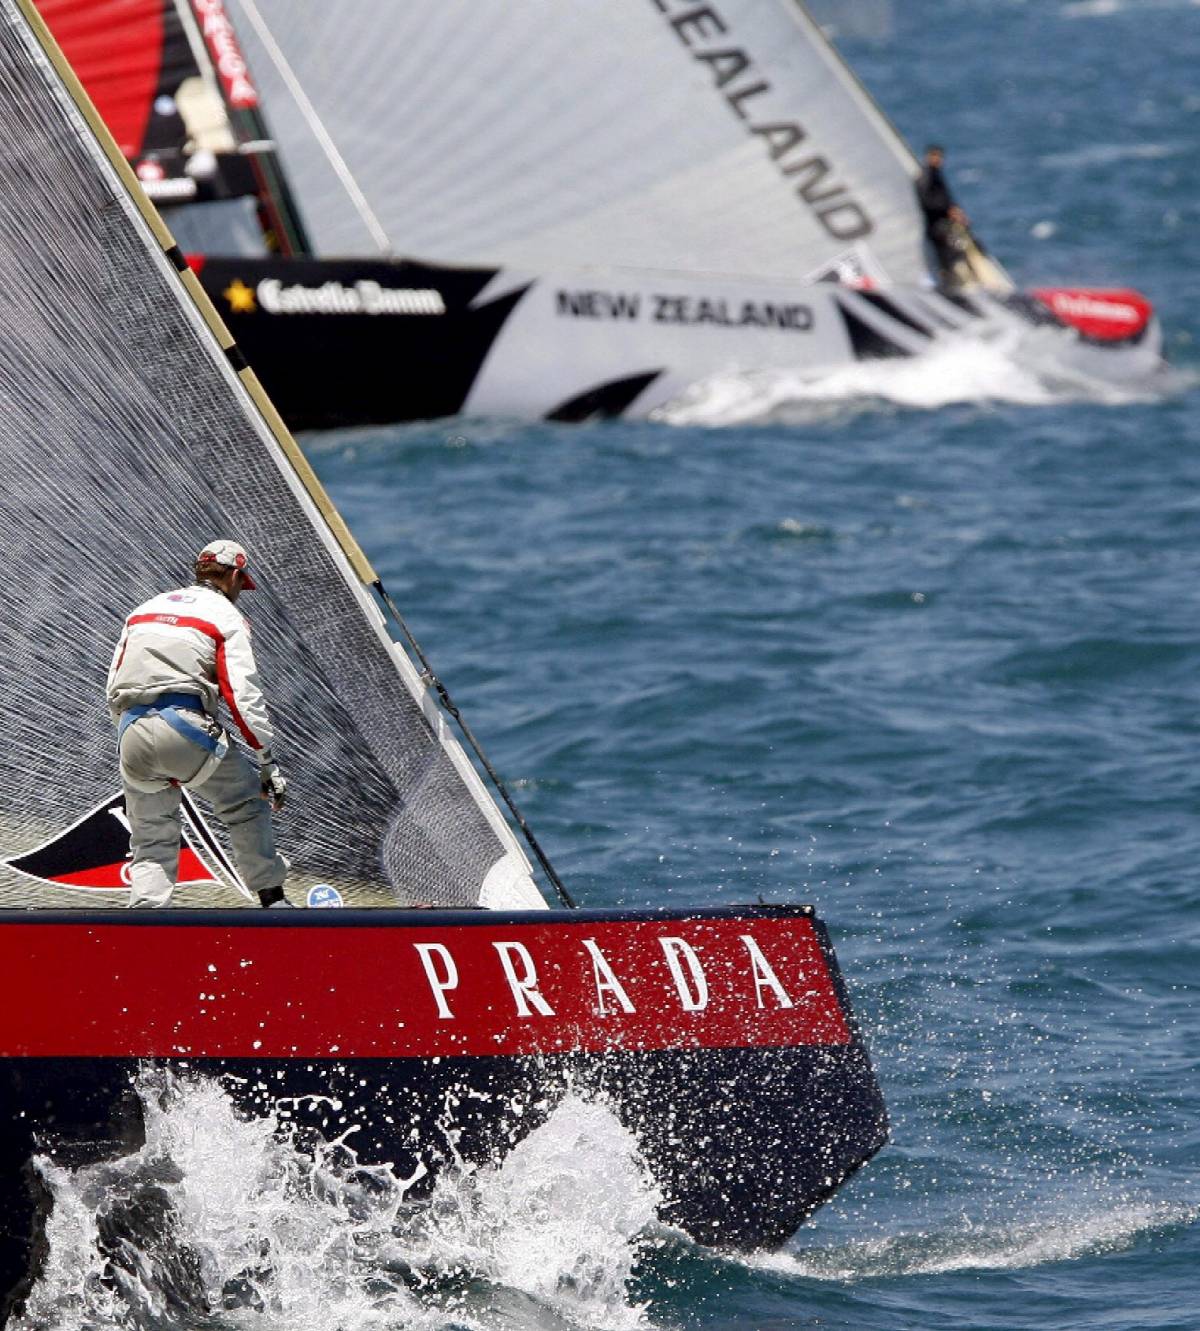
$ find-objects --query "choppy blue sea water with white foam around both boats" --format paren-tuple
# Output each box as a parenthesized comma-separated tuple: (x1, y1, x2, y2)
(18, 0, 1200, 1331)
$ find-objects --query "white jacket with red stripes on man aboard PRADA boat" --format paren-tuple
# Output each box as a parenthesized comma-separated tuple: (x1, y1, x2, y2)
(106, 584, 274, 763)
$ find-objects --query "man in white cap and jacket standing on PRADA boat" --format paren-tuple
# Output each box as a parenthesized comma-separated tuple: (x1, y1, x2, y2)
(106, 540, 291, 906)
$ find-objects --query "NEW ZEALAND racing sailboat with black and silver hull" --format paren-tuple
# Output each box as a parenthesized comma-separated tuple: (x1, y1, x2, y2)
(40, 0, 1163, 427)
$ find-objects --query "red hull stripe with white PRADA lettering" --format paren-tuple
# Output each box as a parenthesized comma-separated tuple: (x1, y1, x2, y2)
(0, 914, 850, 1059)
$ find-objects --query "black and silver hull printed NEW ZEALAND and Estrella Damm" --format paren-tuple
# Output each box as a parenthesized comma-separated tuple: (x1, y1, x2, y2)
(190, 256, 1163, 429)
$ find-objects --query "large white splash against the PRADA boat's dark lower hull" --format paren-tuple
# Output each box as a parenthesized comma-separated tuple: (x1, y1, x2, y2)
(12, 1077, 660, 1331)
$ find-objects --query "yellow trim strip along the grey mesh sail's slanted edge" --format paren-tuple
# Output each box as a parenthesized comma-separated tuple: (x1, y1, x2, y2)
(15, 0, 379, 586)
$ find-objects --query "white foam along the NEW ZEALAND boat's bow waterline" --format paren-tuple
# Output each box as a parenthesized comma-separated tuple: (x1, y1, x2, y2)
(656, 337, 1184, 426)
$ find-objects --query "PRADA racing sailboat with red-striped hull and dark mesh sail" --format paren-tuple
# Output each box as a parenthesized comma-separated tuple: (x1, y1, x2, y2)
(0, 0, 887, 1320)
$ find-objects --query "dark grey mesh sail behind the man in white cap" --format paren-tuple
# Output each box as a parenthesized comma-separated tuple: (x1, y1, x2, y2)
(0, 0, 540, 906)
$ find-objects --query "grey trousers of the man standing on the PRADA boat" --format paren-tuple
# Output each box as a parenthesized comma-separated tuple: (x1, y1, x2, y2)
(121, 716, 287, 906)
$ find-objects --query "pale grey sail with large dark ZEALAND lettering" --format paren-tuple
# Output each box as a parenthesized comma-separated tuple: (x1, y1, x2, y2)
(227, 0, 926, 281)
